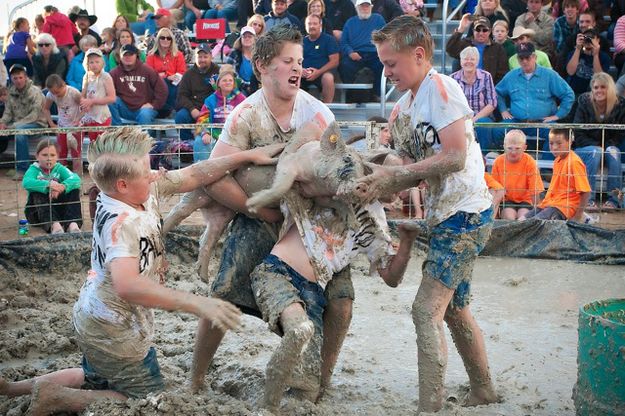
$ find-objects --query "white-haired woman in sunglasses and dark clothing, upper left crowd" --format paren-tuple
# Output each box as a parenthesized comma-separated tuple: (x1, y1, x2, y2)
(33, 33, 67, 90)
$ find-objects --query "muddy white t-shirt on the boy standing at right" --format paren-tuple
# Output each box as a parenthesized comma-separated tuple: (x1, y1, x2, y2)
(390, 69, 492, 226)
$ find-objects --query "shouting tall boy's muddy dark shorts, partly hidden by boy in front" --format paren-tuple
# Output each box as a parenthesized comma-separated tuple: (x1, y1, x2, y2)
(211, 214, 354, 317)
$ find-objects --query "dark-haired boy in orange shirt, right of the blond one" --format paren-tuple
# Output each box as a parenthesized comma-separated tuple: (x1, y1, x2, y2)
(519, 129, 590, 222)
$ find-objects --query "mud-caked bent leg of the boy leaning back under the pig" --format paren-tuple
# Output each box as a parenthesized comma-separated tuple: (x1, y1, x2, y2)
(263, 303, 315, 412)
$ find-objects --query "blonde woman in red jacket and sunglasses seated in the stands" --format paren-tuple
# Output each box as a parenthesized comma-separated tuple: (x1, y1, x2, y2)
(145, 27, 187, 113)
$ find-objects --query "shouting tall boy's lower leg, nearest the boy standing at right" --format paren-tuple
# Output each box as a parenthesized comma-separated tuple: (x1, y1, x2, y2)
(317, 298, 353, 394)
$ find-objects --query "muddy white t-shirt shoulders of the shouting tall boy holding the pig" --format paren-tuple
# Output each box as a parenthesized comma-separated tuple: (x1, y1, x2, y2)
(219, 88, 334, 150)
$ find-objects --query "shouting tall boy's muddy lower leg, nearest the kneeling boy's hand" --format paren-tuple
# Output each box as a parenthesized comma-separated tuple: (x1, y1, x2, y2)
(191, 319, 226, 392)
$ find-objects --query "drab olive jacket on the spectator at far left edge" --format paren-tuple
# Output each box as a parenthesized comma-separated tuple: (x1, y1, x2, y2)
(0, 79, 48, 128)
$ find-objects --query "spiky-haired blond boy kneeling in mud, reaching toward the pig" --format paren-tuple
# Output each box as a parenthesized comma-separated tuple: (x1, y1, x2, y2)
(0, 128, 283, 415)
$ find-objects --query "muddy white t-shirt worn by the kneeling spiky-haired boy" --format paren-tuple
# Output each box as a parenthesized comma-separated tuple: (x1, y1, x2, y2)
(73, 182, 171, 362)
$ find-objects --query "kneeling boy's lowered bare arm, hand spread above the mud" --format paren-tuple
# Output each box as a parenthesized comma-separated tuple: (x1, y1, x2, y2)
(110, 257, 241, 331)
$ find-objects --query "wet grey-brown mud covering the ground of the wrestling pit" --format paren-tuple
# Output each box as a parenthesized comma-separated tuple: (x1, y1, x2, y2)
(0, 242, 625, 416)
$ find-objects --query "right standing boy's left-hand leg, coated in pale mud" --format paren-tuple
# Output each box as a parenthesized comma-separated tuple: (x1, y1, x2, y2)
(412, 276, 454, 413)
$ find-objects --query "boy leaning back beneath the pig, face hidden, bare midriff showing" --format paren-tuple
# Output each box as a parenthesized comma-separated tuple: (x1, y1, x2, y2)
(248, 131, 417, 412)
